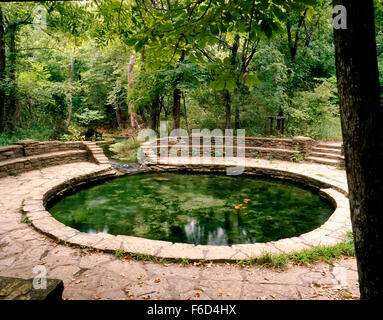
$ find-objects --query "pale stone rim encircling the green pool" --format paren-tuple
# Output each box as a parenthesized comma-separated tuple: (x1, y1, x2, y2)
(23, 165, 351, 261)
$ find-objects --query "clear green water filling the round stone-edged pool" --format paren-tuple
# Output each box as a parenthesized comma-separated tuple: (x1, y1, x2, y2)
(50, 173, 333, 245)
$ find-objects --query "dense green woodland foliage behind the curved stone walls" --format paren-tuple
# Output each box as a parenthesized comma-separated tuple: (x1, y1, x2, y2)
(0, 0, 364, 144)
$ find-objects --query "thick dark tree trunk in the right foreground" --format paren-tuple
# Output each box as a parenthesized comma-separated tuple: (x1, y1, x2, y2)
(334, 0, 383, 299)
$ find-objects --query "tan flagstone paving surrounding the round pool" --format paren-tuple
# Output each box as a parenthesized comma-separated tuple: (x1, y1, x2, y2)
(0, 160, 359, 300)
